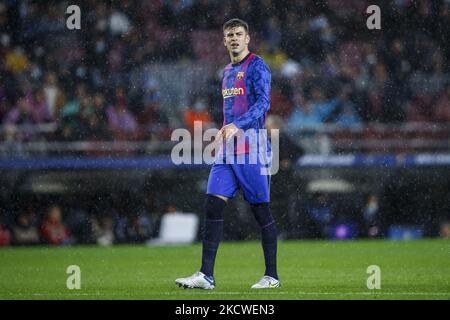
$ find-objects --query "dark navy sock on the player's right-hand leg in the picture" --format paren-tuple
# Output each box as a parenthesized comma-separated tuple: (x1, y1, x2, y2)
(251, 203, 278, 279)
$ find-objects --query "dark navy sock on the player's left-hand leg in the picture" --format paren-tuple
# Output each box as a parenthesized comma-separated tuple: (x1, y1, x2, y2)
(200, 195, 226, 277)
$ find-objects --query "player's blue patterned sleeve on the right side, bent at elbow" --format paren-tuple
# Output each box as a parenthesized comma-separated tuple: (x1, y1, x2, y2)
(234, 60, 272, 131)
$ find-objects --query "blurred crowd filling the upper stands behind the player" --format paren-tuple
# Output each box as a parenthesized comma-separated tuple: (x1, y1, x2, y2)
(0, 0, 450, 145)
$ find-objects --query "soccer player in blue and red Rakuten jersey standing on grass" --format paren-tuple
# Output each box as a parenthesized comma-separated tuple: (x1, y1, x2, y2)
(175, 19, 281, 289)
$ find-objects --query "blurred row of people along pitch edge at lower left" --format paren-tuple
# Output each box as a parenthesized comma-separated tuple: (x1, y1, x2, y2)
(0, 195, 172, 246)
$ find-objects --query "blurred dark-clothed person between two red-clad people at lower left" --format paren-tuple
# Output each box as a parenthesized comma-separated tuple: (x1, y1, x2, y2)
(12, 211, 40, 245)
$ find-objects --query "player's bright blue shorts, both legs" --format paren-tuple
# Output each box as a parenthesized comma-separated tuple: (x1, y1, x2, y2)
(206, 154, 270, 204)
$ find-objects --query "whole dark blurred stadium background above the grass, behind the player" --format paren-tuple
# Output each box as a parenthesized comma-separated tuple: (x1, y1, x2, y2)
(0, 0, 450, 245)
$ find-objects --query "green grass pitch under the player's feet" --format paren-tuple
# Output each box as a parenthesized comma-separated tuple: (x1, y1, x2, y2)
(0, 239, 450, 300)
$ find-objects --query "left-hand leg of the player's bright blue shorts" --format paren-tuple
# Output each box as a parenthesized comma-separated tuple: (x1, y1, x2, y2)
(206, 164, 238, 198)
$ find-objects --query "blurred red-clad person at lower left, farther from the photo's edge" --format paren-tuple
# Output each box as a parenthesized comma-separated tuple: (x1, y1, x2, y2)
(41, 205, 73, 245)
